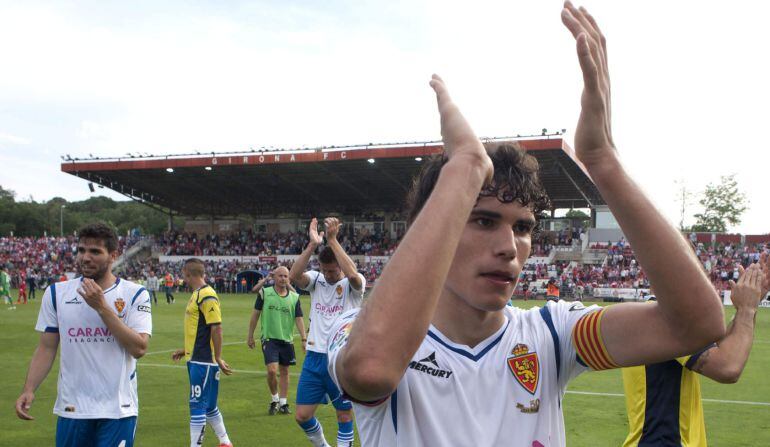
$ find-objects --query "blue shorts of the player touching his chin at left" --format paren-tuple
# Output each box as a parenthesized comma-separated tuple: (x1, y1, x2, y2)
(56, 416, 136, 447)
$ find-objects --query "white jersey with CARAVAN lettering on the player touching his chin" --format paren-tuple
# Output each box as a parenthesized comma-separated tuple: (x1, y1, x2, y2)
(35, 278, 152, 419)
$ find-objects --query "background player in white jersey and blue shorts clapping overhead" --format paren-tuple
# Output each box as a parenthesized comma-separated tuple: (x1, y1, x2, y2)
(289, 217, 366, 447)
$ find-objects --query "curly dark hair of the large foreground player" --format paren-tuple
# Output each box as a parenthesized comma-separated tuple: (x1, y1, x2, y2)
(406, 141, 551, 225)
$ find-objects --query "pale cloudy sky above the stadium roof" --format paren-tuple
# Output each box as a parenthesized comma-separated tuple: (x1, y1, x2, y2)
(0, 0, 770, 233)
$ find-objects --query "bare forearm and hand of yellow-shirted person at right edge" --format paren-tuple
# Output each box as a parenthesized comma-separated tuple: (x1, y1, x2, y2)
(692, 259, 767, 383)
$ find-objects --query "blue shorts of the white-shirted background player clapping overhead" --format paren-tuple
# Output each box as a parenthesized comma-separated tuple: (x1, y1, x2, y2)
(297, 351, 353, 410)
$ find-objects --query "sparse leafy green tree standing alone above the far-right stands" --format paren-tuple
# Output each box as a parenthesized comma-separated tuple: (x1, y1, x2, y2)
(691, 174, 748, 233)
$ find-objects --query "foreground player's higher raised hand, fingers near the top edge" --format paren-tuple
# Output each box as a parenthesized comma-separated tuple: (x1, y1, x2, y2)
(561, 1, 615, 168)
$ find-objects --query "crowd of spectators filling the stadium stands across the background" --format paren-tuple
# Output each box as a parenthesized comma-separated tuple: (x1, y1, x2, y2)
(0, 228, 770, 295)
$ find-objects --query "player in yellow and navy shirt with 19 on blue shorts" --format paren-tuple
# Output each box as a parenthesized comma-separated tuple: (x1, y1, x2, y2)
(171, 258, 232, 447)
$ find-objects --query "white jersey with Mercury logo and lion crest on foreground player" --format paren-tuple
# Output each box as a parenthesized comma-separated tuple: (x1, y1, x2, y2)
(329, 301, 599, 447)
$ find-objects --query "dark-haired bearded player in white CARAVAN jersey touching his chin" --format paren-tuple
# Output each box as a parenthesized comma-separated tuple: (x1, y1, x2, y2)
(16, 224, 152, 447)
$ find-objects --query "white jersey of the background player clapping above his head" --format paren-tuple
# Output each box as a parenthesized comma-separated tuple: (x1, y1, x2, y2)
(305, 270, 366, 354)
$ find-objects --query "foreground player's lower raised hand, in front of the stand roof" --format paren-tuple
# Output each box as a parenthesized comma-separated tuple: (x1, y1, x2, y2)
(430, 74, 494, 184)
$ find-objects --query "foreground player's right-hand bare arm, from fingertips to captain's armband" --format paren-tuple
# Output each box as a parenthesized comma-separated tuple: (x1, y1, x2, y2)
(562, 2, 725, 366)
